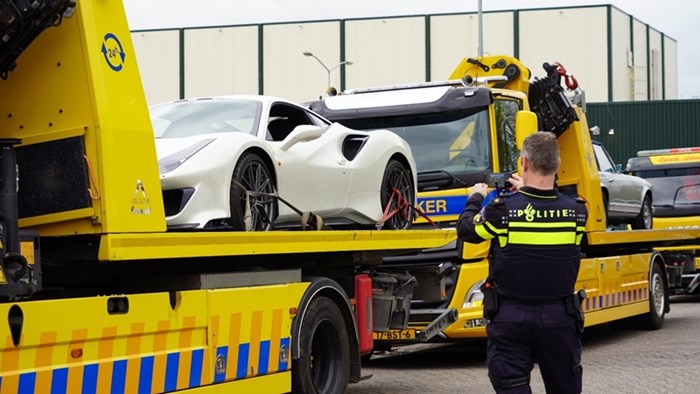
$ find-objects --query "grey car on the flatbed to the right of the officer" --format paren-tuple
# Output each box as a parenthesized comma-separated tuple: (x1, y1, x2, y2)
(593, 141, 653, 229)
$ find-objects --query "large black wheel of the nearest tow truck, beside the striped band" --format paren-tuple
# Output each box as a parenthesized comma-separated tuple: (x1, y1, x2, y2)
(292, 297, 350, 394)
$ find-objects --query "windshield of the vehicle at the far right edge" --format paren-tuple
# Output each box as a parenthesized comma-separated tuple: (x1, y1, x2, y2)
(632, 167, 700, 216)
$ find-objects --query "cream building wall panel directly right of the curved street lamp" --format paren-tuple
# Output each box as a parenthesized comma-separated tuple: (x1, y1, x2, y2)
(345, 17, 425, 88)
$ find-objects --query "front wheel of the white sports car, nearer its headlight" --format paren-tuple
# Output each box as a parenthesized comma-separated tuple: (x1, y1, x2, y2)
(230, 153, 277, 231)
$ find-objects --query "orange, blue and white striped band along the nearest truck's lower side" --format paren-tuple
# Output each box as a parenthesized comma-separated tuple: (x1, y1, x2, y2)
(0, 309, 291, 394)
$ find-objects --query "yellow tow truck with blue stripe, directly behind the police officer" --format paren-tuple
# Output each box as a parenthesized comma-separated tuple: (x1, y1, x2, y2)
(307, 55, 700, 344)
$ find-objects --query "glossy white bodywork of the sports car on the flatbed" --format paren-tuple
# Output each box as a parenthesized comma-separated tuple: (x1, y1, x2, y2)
(156, 96, 417, 228)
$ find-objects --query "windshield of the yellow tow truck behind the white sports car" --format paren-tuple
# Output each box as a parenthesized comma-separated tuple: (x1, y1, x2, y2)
(342, 109, 491, 173)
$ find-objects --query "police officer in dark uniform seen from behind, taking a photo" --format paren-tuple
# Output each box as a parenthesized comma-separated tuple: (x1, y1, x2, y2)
(457, 132, 587, 393)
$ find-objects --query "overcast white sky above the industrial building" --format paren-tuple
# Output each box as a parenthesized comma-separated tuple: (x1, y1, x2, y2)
(123, 0, 700, 98)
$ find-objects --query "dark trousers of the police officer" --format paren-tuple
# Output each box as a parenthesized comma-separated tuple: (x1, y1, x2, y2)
(486, 302, 583, 394)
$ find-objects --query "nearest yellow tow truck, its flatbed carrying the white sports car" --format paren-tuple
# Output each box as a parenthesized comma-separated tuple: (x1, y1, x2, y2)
(0, 0, 455, 394)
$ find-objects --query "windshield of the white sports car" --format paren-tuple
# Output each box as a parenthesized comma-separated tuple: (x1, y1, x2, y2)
(150, 99, 262, 138)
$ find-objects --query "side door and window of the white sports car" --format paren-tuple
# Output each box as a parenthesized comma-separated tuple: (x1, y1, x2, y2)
(268, 103, 351, 219)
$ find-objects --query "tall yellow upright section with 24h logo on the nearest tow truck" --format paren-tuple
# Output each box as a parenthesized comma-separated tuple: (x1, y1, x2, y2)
(0, 0, 165, 236)
